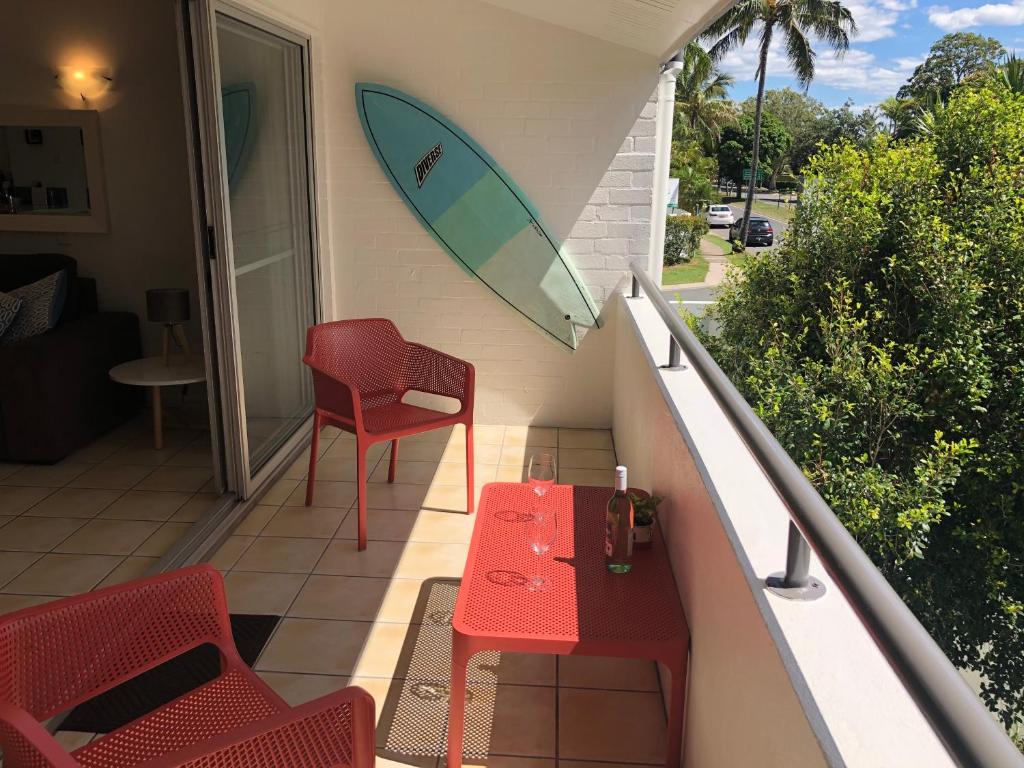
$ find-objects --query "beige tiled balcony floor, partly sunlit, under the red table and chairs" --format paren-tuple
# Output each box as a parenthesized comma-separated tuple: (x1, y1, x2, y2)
(213, 426, 666, 768)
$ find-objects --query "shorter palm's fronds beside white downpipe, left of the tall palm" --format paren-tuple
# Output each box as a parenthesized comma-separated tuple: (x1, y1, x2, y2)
(676, 42, 736, 154)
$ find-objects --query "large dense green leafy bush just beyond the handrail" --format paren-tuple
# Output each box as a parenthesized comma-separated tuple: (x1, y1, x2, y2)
(705, 86, 1024, 726)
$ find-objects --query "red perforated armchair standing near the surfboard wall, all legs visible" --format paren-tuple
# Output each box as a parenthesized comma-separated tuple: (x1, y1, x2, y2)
(302, 317, 474, 550)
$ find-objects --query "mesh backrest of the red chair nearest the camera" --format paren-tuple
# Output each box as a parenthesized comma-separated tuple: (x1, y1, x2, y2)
(0, 569, 233, 720)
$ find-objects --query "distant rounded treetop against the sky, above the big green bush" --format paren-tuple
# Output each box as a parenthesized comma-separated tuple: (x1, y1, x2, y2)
(896, 32, 1007, 100)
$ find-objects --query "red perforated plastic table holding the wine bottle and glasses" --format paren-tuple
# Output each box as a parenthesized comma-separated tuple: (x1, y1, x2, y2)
(447, 482, 689, 768)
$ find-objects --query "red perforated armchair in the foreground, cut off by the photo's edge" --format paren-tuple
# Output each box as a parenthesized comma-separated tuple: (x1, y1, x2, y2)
(0, 565, 375, 768)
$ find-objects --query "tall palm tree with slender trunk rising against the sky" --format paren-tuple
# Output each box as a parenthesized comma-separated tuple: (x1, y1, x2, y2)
(702, 0, 857, 245)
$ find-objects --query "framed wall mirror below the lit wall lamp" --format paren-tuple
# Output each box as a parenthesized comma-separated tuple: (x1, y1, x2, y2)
(0, 106, 106, 232)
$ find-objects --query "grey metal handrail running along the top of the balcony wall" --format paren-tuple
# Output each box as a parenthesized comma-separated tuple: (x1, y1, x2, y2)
(630, 259, 1024, 768)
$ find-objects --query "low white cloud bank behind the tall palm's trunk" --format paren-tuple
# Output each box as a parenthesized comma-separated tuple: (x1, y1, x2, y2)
(720, 36, 922, 97)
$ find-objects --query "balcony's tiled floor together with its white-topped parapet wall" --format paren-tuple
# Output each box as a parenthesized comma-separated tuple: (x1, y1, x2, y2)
(0, 274, 1011, 766)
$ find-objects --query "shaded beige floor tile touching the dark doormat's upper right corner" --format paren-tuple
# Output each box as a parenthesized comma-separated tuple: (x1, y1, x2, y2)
(256, 618, 372, 676)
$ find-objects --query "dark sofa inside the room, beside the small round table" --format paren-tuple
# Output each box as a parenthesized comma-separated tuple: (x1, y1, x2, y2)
(0, 253, 143, 462)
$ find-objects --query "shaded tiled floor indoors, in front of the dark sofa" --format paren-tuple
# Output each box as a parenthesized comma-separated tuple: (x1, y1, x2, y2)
(0, 416, 217, 613)
